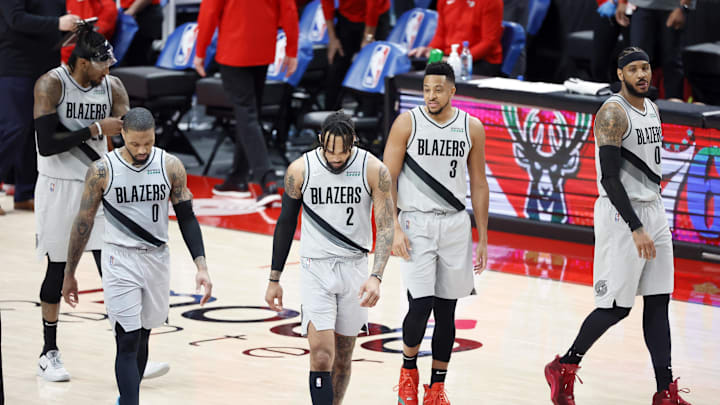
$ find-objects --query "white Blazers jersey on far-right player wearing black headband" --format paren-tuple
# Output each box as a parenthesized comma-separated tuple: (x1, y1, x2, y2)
(595, 94, 662, 201)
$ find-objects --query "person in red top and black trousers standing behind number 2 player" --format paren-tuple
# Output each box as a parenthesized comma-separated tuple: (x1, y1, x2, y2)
(322, 0, 390, 110)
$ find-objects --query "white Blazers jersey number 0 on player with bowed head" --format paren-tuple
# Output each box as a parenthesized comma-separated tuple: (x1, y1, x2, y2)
(102, 148, 170, 249)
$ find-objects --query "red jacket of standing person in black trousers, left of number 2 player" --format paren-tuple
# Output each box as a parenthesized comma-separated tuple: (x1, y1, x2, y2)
(195, 0, 298, 66)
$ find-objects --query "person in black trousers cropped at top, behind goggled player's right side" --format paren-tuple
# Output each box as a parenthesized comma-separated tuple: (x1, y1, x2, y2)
(120, 0, 163, 66)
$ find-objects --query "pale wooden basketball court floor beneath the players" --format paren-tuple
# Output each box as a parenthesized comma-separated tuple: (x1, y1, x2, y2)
(0, 184, 720, 405)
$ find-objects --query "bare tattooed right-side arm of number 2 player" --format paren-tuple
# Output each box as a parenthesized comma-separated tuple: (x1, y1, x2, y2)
(368, 157, 395, 276)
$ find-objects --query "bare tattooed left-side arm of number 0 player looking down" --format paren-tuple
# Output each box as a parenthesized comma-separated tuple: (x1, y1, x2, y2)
(65, 159, 108, 276)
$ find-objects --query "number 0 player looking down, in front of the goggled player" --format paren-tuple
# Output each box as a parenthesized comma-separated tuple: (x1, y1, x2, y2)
(62, 107, 212, 405)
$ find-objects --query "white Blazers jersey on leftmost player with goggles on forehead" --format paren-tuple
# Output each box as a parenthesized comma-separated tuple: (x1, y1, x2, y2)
(36, 66, 112, 181)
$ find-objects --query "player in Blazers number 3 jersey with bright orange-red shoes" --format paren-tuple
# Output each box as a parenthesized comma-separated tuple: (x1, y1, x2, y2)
(383, 62, 489, 405)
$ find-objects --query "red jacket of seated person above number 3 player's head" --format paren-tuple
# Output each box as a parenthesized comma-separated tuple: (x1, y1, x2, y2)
(429, 0, 503, 64)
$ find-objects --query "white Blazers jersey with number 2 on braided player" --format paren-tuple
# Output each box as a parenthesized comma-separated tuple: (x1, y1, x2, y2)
(300, 147, 372, 259)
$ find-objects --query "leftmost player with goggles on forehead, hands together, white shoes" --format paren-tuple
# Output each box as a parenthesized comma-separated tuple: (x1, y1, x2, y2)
(34, 24, 129, 381)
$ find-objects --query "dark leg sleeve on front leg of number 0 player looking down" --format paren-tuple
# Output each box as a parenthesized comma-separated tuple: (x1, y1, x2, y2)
(115, 323, 141, 405)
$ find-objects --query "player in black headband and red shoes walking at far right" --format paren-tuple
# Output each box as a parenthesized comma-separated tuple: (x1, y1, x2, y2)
(545, 47, 689, 405)
